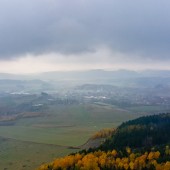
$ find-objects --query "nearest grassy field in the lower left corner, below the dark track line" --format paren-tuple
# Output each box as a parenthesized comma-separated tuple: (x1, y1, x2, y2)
(0, 138, 76, 170)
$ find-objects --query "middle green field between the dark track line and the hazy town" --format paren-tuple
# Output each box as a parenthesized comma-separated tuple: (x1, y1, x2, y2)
(0, 105, 136, 146)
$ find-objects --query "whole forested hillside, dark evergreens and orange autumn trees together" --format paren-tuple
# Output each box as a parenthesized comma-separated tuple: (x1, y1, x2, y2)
(38, 113, 170, 170)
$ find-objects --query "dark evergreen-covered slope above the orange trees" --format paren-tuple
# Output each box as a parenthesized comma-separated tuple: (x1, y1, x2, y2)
(101, 114, 170, 150)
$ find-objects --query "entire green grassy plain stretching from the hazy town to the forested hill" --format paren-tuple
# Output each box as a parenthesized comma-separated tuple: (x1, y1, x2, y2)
(0, 104, 160, 170)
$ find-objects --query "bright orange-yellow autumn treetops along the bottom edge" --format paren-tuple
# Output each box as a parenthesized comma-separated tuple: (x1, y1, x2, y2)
(38, 148, 170, 170)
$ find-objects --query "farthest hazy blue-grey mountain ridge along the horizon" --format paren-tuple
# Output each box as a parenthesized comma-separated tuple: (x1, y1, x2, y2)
(0, 69, 170, 80)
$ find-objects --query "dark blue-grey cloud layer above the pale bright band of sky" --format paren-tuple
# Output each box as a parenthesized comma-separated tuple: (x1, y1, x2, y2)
(0, 0, 170, 60)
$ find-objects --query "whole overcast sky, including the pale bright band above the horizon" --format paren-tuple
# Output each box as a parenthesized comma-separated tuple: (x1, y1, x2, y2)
(0, 0, 170, 73)
